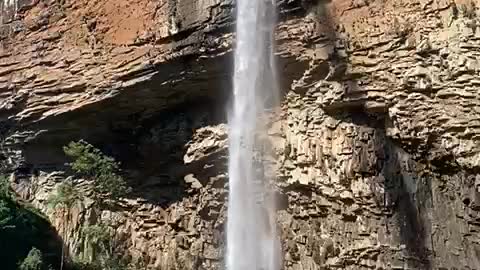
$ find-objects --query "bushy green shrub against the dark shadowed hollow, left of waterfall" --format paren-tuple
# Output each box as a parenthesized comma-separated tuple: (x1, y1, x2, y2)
(63, 141, 130, 200)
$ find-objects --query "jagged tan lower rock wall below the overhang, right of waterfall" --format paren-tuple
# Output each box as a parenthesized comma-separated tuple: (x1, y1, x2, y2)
(281, 94, 479, 269)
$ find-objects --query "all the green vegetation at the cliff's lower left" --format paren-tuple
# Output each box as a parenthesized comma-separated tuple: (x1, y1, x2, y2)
(0, 141, 129, 270)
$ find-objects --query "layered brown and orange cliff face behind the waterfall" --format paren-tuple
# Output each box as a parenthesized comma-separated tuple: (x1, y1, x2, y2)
(0, 0, 480, 270)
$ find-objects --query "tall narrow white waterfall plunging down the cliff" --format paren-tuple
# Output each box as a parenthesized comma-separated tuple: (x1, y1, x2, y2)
(226, 0, 281, 270)
